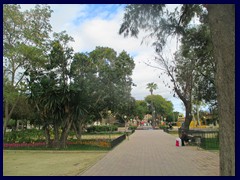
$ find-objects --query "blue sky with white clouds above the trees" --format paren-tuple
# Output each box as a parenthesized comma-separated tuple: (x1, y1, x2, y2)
(21, 4, 184, 113)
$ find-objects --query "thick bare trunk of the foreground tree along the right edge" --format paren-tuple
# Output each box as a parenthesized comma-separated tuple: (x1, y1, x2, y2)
(207, 4, 235, 176)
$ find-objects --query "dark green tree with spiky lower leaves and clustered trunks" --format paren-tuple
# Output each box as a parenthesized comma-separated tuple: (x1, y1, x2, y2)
(28, 32, 74, 148)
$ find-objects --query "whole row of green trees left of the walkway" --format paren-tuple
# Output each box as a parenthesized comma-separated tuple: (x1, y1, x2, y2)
(3, 5, 135, 148)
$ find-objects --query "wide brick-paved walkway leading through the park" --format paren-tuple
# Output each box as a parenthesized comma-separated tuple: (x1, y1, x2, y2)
(81, 130, 219, 176)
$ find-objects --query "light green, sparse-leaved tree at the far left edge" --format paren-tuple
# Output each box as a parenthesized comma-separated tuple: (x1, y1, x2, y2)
(3, 4, 52, 133)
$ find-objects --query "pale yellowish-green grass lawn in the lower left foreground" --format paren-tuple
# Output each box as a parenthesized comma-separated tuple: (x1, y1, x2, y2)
(3, 150, 108, 176)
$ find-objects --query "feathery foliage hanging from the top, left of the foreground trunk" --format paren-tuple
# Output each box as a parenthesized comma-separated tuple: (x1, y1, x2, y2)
(119, 4, 204, 52)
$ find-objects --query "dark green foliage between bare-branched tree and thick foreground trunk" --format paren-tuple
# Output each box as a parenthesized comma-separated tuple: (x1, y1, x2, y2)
(181, 24, 216, 104)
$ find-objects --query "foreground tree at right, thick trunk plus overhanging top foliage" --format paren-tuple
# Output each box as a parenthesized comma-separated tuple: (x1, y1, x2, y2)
(119, 4, 235, 175)
